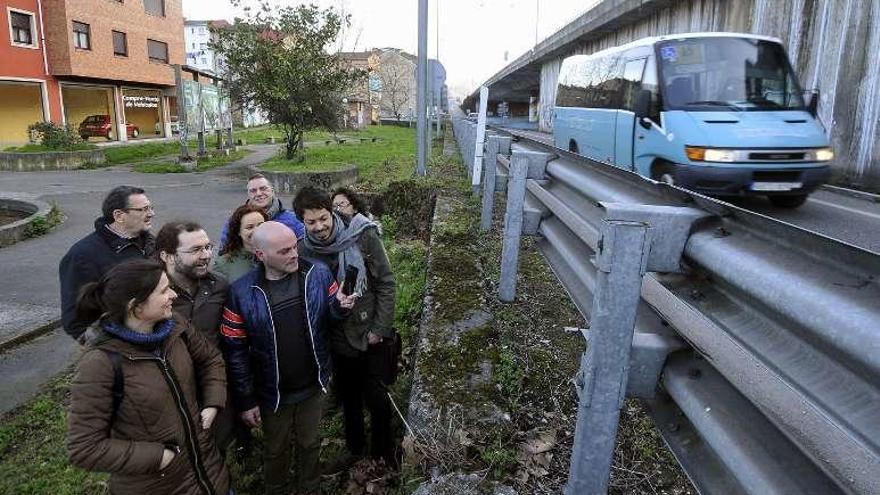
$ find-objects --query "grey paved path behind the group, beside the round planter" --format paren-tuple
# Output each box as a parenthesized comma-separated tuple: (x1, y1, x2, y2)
(0, 145, 282, 409)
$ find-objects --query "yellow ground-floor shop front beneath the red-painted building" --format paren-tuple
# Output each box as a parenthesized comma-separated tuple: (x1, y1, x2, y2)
(0, 80, 45, 148)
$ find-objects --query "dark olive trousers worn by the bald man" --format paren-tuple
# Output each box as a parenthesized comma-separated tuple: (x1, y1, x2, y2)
(260, 392, 324, 495)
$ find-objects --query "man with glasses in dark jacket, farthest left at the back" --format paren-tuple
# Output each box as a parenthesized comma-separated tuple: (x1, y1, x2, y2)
(58, 186, 154, 343)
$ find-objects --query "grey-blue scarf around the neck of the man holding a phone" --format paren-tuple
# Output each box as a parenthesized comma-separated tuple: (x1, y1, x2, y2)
(303, 212, 376, 297)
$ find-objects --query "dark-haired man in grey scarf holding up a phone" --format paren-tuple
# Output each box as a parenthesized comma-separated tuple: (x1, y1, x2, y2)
(293, 187, 400, 468)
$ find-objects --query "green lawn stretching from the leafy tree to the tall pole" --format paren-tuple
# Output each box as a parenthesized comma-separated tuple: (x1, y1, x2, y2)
(263, 126, 416, 189)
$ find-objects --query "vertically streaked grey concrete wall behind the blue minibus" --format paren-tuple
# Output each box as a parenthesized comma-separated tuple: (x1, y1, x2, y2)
(539, 0, 880, 188)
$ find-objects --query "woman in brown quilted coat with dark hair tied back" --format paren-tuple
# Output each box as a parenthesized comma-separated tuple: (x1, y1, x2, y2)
(67, 260, 230, 495)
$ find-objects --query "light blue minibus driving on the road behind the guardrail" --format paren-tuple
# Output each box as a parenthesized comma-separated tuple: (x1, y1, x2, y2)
(552, 33, 834, 208)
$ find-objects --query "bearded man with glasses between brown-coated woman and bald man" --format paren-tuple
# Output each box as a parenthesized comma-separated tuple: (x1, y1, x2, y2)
(156, 221, 251, 453)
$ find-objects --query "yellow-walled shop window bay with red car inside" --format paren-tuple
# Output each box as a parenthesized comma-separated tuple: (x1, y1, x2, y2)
(61, 84, 118, 141)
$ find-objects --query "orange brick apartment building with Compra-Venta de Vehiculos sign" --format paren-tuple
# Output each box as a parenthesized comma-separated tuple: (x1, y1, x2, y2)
(43, 0, 184, 141)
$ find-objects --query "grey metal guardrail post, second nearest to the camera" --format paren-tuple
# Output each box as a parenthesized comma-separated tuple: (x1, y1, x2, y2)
(496, 152, 531, 302)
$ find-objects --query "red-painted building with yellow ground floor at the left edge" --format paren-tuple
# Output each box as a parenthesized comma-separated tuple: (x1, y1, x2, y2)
(0, 0, 61, 147)
